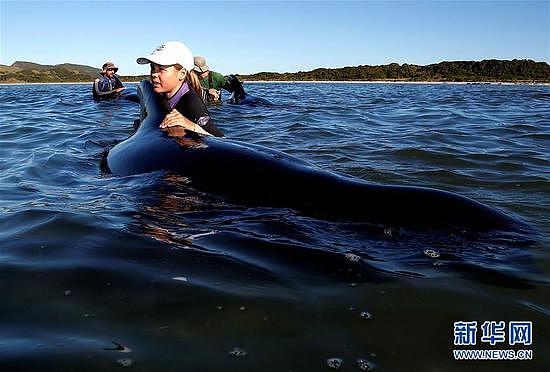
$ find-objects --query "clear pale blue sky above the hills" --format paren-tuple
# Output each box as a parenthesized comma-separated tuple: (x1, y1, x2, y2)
(0, 0, 550, 75)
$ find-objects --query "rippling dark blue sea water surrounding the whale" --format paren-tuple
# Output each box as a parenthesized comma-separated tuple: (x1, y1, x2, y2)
(0, 83, 550, 371)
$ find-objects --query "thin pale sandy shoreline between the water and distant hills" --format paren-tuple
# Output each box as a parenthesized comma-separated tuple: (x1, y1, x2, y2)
(0, 80, 550, 86)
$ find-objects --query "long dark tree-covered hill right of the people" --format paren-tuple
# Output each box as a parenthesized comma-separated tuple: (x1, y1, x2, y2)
(238, 59, 550, 83)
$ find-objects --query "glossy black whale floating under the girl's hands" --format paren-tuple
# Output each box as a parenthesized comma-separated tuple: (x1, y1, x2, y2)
(106, 81, 523, 231)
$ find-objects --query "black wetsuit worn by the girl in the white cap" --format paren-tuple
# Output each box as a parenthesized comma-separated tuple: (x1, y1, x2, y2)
(159, 89, 224, 137)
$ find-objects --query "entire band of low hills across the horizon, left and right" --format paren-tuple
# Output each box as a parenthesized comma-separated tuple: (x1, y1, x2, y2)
(0, 59, 550, 83)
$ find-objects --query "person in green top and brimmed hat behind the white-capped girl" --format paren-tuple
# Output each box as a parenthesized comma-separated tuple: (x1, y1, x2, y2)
(193, 56, 246, 103)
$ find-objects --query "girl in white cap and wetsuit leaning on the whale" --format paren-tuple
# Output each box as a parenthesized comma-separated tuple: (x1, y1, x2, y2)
(137, 41, 223, 137)
